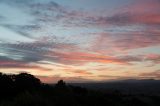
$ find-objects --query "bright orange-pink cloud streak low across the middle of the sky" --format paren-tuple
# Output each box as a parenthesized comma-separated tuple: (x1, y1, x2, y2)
(49, 52, 141, 64)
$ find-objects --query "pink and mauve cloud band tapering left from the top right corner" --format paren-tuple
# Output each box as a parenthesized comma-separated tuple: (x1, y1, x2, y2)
(86, 0, 160, 27)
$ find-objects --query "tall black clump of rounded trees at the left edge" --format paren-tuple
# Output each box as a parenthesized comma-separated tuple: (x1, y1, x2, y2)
(0, 73, 42, 99)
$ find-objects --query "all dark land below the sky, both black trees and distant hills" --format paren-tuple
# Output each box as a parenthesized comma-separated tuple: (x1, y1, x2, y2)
(0, 73, 160, 106)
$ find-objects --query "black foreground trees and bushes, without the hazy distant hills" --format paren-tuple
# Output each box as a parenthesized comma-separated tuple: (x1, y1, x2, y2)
(0, 73, 160, 106)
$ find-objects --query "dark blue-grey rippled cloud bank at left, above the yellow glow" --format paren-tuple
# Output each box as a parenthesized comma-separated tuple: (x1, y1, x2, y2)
(0, 37, 78, 63)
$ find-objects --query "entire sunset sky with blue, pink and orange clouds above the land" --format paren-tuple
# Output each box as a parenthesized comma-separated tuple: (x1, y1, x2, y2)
(0, 0, 160, 83)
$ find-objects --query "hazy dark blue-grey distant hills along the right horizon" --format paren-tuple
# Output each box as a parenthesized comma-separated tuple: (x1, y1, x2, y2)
(70, 79, 160, 95)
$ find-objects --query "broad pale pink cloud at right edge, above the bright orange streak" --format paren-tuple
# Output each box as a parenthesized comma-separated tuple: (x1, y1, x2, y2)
(91, 29, 160, 54)
